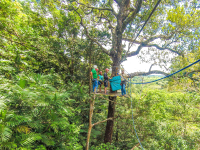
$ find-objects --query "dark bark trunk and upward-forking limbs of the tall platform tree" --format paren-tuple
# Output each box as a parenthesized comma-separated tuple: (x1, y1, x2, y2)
(77, 0, 142, 143)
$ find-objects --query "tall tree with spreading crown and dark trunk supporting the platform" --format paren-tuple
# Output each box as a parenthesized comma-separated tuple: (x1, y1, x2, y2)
(63, 0, 199, 143)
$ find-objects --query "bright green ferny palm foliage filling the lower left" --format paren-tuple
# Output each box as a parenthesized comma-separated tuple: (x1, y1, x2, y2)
(0, 73, 81, 149)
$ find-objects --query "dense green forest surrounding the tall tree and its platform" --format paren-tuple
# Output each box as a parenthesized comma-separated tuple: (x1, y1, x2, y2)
(0, 0, 200, 150)
